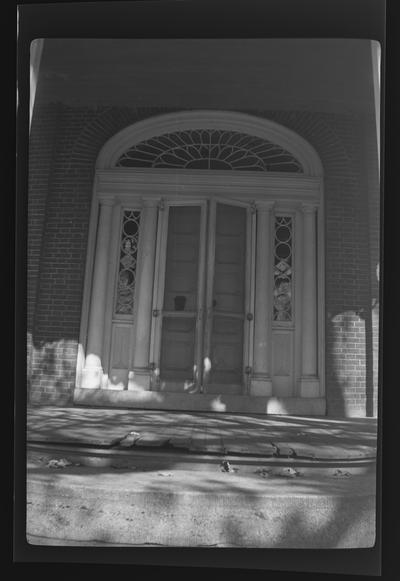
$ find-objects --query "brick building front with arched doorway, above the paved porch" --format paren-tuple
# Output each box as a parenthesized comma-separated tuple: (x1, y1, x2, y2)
(28, 39, 380, 416)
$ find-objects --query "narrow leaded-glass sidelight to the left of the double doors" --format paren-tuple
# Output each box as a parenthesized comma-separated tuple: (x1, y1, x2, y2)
(115, 210, 140, 315)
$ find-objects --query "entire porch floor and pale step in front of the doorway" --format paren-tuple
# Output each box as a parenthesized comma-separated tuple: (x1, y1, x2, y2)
(27, 407, 376, 548)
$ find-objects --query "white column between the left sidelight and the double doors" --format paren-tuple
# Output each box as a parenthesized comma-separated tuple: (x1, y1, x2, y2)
(128, 201, 158, 390)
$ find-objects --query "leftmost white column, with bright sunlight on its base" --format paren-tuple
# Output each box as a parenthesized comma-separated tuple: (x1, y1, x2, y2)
(82, 199, 113, 389)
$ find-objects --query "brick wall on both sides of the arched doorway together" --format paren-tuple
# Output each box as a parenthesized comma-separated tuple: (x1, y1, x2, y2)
(28, 104, 379, 416)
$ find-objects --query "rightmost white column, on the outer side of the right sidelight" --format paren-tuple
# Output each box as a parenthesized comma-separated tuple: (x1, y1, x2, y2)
(300, 204, 319, 397)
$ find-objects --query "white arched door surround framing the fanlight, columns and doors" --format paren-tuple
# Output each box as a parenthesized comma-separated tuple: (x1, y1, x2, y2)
(74, 110, 325, 414)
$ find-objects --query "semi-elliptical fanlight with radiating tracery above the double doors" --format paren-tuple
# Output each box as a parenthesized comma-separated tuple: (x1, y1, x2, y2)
(115, 129, 303, 173)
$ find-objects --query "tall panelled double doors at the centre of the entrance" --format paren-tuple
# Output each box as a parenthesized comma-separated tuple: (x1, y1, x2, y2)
(151, 199, 254, 394)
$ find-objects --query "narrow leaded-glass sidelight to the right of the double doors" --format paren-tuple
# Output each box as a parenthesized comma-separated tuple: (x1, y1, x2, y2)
(273, 216, 293, 321)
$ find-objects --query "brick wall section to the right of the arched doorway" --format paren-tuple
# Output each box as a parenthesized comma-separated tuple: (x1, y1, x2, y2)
(270, 113, 379, 416)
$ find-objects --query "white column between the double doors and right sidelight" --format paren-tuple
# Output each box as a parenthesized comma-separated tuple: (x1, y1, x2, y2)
(250, 202, 273, 396)
